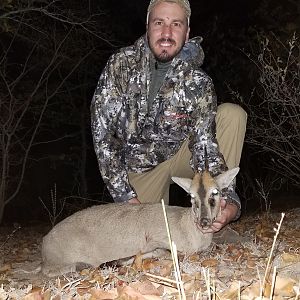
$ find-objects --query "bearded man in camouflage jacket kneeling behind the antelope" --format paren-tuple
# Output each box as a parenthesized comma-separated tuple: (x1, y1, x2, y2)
(91, 0, 246, 232)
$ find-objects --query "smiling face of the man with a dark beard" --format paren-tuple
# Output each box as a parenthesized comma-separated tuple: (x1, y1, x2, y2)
(147, 2, 190, 62)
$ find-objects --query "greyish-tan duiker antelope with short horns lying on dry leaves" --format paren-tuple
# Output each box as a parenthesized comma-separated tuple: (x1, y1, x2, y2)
(42, 168, 238, 276)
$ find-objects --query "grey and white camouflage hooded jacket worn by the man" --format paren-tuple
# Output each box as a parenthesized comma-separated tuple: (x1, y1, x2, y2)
(91, 36, 239, 211)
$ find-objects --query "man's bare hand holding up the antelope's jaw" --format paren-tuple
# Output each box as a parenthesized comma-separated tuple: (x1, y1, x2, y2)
(202, 199, 238, 233)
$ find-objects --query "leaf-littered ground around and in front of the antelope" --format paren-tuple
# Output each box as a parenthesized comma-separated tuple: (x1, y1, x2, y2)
(0, 208, 300, 300)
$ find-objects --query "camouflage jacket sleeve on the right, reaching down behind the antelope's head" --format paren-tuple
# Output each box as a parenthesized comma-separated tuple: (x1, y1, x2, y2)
(189, 77, 241, 219)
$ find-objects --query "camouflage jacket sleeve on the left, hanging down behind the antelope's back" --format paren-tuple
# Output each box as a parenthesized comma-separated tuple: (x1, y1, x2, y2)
(91, 56, 136, 202)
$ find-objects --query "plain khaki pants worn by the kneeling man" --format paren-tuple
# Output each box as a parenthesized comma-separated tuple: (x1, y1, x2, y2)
(128, 103, 247, 204)
